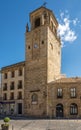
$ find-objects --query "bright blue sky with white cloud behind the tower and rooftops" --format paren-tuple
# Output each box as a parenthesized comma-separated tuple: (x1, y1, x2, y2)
(0, 0, 81, 77)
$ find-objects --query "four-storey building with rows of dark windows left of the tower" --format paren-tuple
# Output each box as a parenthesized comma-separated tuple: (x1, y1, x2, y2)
(0, 62, 25, 115)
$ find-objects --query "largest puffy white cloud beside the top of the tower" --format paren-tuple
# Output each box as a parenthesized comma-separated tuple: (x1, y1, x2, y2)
(58, 11, 79, 45)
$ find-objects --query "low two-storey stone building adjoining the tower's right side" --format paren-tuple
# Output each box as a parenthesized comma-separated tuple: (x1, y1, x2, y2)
(48, 77, 81, 118)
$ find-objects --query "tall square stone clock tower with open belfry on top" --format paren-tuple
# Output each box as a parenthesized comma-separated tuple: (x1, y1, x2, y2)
(24, 7, 61, 116)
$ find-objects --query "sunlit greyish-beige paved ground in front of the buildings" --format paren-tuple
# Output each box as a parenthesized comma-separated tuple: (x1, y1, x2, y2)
(0, 119, 81, 130)
